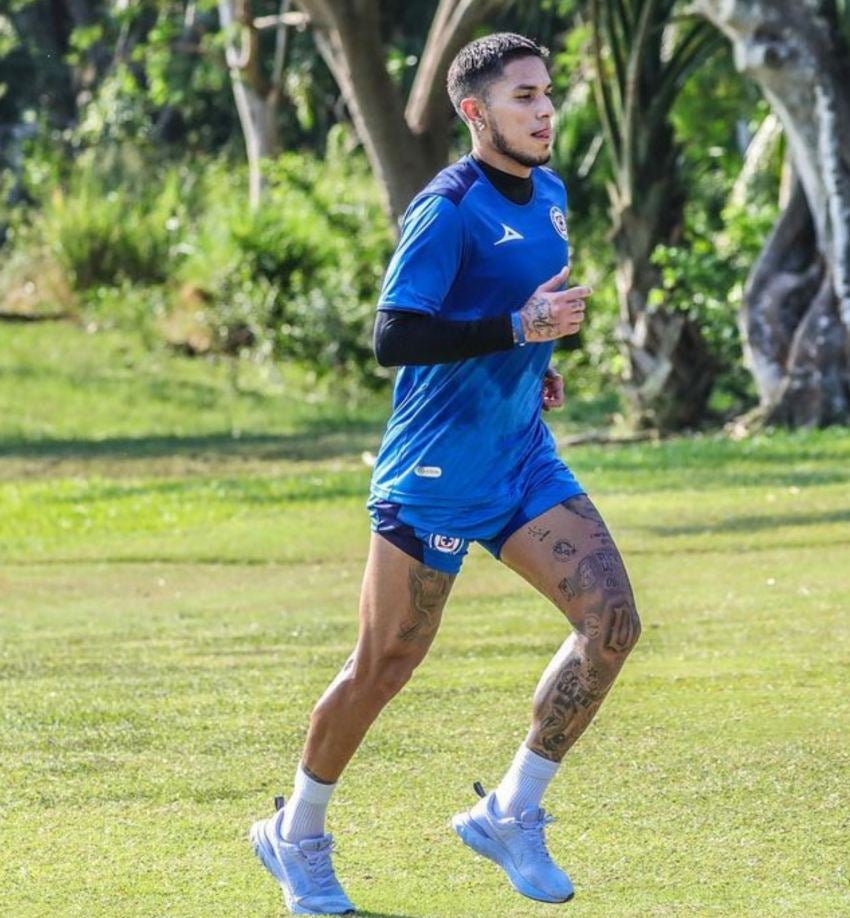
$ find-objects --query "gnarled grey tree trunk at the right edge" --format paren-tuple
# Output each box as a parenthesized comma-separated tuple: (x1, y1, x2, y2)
(693, 0, 850, 427)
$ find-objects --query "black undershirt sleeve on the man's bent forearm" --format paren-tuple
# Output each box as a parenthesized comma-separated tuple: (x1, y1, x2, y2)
(372, 309, 514, 367)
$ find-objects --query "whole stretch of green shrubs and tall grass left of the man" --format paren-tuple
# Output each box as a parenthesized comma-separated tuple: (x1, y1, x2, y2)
(7, 135, 393, 384)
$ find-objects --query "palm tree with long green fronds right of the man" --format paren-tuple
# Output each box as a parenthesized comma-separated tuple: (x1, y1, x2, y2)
(591, 0, 720, 429)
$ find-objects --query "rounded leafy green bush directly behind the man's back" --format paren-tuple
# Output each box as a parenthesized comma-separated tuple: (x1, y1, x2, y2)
(178, 134, 392, 383)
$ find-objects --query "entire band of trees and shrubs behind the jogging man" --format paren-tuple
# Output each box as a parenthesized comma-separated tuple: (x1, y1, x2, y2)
(0, 0, 850, 430)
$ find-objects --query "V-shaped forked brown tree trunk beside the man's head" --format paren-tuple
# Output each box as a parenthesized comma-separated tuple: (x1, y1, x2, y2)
(298, 0, 511, 222)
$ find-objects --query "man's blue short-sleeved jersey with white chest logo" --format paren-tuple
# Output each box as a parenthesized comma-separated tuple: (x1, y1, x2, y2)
(372, 156, 569, 508)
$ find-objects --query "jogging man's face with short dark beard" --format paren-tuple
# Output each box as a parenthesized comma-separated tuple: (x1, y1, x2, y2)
(481, 57, 555, 167)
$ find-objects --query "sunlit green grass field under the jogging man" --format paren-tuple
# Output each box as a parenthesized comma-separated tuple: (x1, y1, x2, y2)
(0, 326, 850, 918)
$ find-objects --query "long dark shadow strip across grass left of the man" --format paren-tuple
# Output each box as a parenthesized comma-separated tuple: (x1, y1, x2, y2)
(0, 421, 382, 462)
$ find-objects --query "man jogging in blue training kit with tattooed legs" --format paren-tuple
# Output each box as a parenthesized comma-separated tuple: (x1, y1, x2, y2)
(251, 34, 640, 914)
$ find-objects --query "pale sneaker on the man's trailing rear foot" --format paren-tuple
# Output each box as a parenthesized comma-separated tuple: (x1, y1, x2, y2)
(249, 798, 354, 915)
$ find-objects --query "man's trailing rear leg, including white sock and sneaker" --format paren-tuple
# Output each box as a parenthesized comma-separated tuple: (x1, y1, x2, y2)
(250, 535, 454, 915)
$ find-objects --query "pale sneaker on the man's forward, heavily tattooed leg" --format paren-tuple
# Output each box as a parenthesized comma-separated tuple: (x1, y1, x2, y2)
(452, 785, 573, 902)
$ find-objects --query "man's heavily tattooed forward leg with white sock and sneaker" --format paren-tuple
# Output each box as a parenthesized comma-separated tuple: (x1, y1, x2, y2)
(452, 496, 640, 902)
